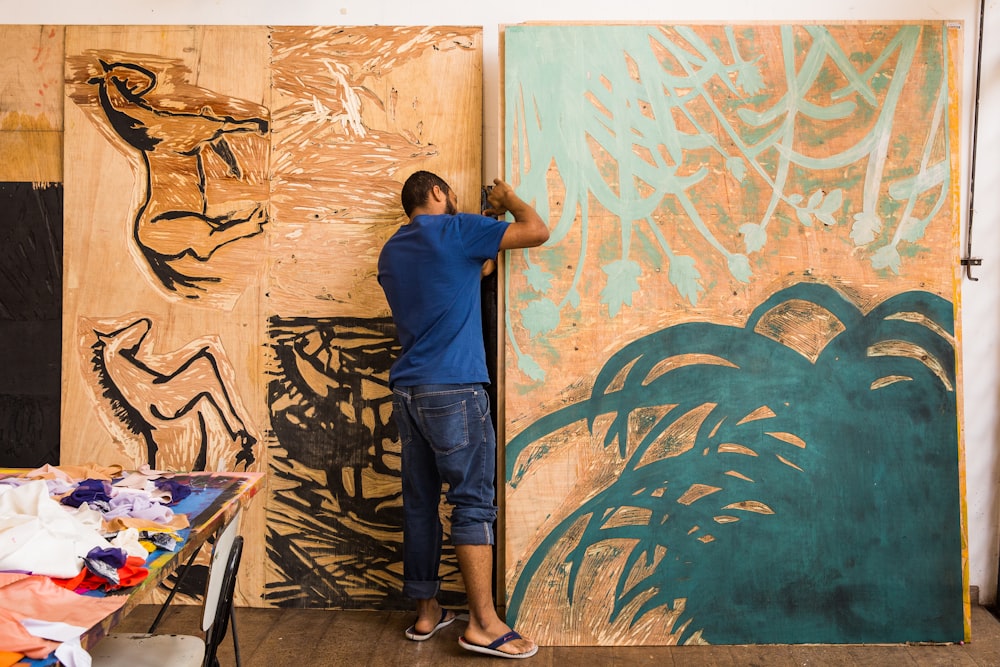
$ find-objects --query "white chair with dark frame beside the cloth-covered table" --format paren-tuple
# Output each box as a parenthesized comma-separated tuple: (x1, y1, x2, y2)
(90, 513, 243, 667)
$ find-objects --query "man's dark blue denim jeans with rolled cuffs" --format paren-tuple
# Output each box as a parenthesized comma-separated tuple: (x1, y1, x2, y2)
(392, 384, 497, 600)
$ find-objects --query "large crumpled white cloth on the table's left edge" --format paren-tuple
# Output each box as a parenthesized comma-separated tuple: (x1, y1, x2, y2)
(0, 480, 111, 579)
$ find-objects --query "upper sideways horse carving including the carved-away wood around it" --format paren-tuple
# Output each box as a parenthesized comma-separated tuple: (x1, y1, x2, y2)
(67, 37, 270, 308)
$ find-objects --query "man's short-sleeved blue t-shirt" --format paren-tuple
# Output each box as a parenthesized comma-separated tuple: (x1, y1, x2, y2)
(378, 213, 510, 386)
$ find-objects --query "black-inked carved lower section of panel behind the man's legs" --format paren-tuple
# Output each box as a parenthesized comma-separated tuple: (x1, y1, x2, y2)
(265, 317, 462, 609)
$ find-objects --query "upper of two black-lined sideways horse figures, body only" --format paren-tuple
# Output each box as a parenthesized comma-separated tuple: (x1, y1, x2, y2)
(73, 53, 270, 299)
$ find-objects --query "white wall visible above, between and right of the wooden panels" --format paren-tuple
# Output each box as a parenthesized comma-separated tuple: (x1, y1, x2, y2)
(9, 0, 1000, 602)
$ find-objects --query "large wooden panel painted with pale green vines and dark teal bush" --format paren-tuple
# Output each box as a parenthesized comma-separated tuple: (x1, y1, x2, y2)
(504, 24, 965, 644)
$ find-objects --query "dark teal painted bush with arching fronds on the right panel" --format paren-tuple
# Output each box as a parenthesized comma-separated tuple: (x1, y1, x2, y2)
(506, 283, 964, 644)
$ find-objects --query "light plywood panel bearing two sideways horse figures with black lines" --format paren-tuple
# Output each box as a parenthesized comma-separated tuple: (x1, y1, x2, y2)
(62, 26, 270, 604)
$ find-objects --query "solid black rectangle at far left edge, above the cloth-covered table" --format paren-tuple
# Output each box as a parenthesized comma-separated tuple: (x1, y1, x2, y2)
(0, 183, 63, 467)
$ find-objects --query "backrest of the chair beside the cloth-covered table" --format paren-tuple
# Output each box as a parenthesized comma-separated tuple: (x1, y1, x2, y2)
(202, 508, 243, 667)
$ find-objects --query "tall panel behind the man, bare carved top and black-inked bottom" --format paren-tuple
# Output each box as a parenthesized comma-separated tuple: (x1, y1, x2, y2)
(265, 27, 482, 609)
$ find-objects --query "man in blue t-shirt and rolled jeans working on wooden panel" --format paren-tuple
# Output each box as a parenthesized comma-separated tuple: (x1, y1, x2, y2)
(378, 171, 549, 658)
